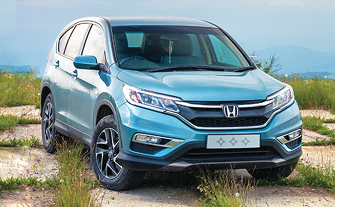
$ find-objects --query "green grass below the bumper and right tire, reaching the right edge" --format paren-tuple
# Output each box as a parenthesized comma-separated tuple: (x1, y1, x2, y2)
(196, 158, 335, 207)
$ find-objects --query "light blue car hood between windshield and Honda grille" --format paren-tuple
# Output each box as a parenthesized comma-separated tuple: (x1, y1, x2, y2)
(118, 69, 285, 101)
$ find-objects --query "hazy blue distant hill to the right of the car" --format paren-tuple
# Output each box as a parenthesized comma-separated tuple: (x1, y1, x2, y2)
(255, 45, 335, 76)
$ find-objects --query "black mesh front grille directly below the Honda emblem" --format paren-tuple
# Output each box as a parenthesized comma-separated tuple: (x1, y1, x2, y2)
(190, 116, 268, 127)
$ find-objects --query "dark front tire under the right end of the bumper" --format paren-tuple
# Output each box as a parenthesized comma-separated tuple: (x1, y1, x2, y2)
(247, 161, 298, 180)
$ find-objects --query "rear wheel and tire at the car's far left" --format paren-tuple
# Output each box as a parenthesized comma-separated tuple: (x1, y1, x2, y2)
(42, 93, 61, 153)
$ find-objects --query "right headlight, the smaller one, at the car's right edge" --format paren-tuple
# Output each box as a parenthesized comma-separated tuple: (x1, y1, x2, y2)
(267, 85, 294, 109)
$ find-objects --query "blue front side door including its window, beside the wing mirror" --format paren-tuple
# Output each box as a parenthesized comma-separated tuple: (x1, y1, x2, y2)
(68, 24, 106, 143)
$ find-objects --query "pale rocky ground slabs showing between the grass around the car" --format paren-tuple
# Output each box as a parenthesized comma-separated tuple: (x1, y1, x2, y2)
(0, 106, 335, 206)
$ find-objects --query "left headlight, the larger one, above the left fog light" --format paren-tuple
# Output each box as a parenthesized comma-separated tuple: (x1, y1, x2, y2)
(123, 84, 181, 113)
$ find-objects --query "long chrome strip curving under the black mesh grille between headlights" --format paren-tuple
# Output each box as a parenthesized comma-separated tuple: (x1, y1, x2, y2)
(164, 99, 294, 130)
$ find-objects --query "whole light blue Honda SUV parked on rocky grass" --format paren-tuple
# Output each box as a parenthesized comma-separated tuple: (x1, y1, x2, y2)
(41, 16, 302, 190)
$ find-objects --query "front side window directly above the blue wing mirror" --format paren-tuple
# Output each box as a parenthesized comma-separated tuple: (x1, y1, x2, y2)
(82, 25, 105, 63)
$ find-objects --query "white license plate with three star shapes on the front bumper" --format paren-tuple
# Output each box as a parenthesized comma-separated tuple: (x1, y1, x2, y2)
(207, 134, 260, 149)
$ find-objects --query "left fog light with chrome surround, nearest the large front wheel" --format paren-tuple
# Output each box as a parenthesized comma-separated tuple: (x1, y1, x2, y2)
(132, 134, 184, 148)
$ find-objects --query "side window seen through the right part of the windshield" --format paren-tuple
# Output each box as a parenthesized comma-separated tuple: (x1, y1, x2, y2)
(209, 34, 241, 66)
